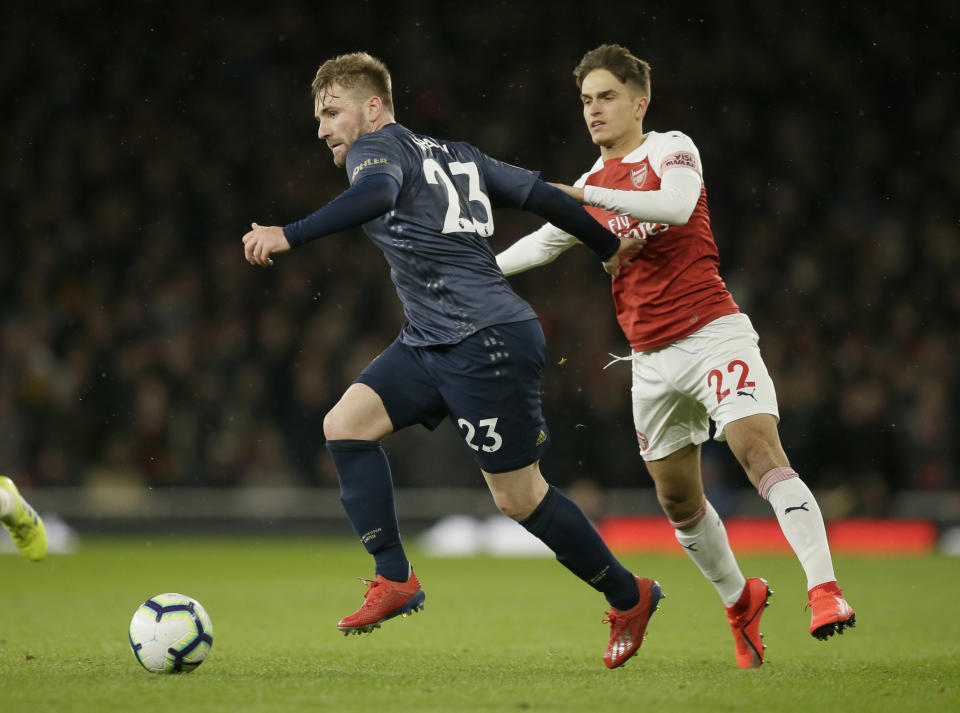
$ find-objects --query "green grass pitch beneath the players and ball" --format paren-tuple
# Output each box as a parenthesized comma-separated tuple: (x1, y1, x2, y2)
(0, 537, 960, 713)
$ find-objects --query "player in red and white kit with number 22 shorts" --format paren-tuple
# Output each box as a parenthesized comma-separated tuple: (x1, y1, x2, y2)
(497, 45, 855, 668)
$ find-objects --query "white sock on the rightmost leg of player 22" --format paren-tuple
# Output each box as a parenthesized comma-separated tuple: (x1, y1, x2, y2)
(757, 468, 837, 590)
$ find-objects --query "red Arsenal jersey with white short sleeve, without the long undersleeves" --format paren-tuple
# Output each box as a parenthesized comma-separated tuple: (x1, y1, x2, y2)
(577, 131, 740, 351)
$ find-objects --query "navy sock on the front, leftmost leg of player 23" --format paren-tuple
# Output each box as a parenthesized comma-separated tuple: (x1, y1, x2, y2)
(327, 440, 410, 582)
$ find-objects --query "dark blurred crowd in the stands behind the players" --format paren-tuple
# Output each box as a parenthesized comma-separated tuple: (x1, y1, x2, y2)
(0, 0, 960, 514)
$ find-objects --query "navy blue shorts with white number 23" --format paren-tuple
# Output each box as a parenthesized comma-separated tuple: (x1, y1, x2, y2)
(356, 319, 550, 473)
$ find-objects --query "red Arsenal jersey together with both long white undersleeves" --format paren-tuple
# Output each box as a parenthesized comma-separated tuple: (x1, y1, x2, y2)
(497, 131, 739, 351)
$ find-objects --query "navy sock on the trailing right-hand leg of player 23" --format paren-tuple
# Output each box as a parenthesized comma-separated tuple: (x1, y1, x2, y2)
(520, 485, 640, 611)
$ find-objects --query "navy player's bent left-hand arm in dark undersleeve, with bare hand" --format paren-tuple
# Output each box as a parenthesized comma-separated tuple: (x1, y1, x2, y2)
(243, 173, 400, 267)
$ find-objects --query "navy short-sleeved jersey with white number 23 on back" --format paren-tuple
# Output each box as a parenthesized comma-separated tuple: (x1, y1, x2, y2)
(346, 124, 539, 346)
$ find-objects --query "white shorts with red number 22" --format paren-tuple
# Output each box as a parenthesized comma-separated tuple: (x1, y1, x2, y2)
(631, 313, 780, 460)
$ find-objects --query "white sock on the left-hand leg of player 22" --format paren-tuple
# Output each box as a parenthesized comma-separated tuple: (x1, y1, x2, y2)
(671, 500, 747, 607)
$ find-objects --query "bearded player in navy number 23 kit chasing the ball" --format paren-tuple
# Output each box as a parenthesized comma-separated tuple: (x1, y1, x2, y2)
(243, 53, 662, 668)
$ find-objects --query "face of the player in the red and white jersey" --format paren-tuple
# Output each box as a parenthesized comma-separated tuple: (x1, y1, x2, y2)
(580, 69, 647, 149)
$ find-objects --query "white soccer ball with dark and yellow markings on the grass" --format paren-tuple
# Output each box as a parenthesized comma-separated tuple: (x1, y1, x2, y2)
(130, 593, 213, 673)
